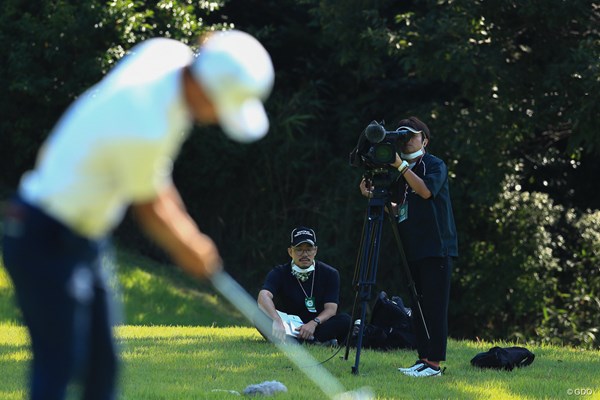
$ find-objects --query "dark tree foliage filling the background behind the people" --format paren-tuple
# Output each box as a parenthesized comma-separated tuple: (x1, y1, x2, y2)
(0, 0, 600, 347)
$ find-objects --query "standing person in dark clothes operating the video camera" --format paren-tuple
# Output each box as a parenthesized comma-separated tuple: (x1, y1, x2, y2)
(360, 117, 458, 377)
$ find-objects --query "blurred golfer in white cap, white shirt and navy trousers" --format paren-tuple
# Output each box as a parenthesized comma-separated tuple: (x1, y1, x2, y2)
(3, 31, 274, 400)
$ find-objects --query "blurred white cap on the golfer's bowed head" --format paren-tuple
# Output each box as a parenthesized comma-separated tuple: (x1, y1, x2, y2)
(191, 30, 275, 142)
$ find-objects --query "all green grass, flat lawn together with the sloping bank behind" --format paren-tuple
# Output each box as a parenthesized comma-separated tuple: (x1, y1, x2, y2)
(0, 248, 600, 400)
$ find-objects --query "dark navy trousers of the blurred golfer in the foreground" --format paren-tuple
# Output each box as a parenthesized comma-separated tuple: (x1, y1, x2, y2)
(2, 198, 117, 400)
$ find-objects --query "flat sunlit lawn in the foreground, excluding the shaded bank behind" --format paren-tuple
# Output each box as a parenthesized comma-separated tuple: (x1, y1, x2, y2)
(0, 318, 600, 400)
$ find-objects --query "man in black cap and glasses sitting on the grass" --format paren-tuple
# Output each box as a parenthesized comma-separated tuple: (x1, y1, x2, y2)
(258, 227, 351, 345)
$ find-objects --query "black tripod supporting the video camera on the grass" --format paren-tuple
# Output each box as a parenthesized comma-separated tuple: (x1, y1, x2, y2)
(344, 169, 430, 375)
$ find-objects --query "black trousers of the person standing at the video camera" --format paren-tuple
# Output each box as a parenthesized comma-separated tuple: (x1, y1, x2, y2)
(409, 257, 452, 361)
